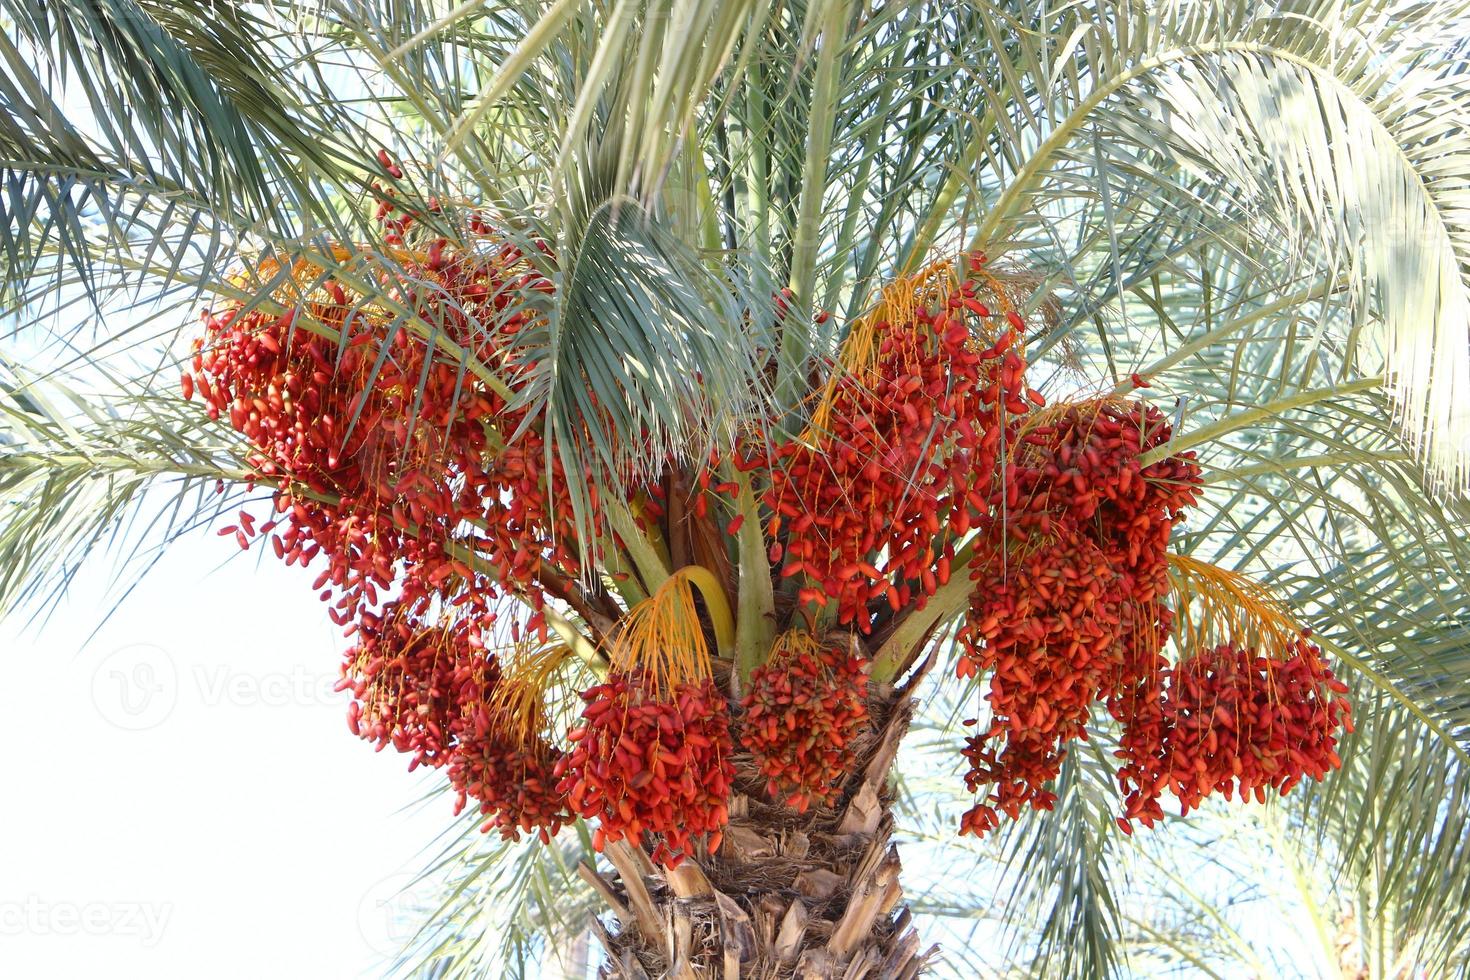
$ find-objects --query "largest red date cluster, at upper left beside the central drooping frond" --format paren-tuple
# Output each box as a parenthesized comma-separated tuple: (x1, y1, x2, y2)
(184, 230, 579, 637)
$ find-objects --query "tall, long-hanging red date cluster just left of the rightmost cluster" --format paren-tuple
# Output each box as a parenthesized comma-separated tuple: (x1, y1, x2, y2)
(957, 398, 1200, 835)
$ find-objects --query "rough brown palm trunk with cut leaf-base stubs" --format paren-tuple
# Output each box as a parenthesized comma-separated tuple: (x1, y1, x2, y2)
(581, 693, 935, 980)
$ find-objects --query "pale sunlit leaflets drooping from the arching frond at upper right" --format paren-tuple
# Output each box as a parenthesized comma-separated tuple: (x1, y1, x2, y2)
(1157, 47, 1470, 492)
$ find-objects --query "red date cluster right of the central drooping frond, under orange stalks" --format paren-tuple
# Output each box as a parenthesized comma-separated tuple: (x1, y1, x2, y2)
(751, 253, 1042, 633)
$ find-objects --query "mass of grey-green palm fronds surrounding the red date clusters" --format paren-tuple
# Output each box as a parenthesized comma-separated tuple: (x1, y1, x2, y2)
(0, 0, 1470, 976)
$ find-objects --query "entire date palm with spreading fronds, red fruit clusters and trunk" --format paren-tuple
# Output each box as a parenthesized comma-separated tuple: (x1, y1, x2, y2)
(0, 0, 1470, 976)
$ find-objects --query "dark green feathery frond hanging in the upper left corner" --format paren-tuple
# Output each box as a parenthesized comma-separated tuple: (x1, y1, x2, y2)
(0, 0, 385, 301)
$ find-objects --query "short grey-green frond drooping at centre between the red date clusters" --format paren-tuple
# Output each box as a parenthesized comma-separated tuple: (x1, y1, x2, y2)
(532, 203, 770, 528)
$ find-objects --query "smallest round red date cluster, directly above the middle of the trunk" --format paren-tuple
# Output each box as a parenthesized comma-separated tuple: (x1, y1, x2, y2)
(741, 641, 867, 813)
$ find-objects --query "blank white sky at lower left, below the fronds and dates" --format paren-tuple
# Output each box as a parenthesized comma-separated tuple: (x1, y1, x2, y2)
(0, 532, 451, 980)
